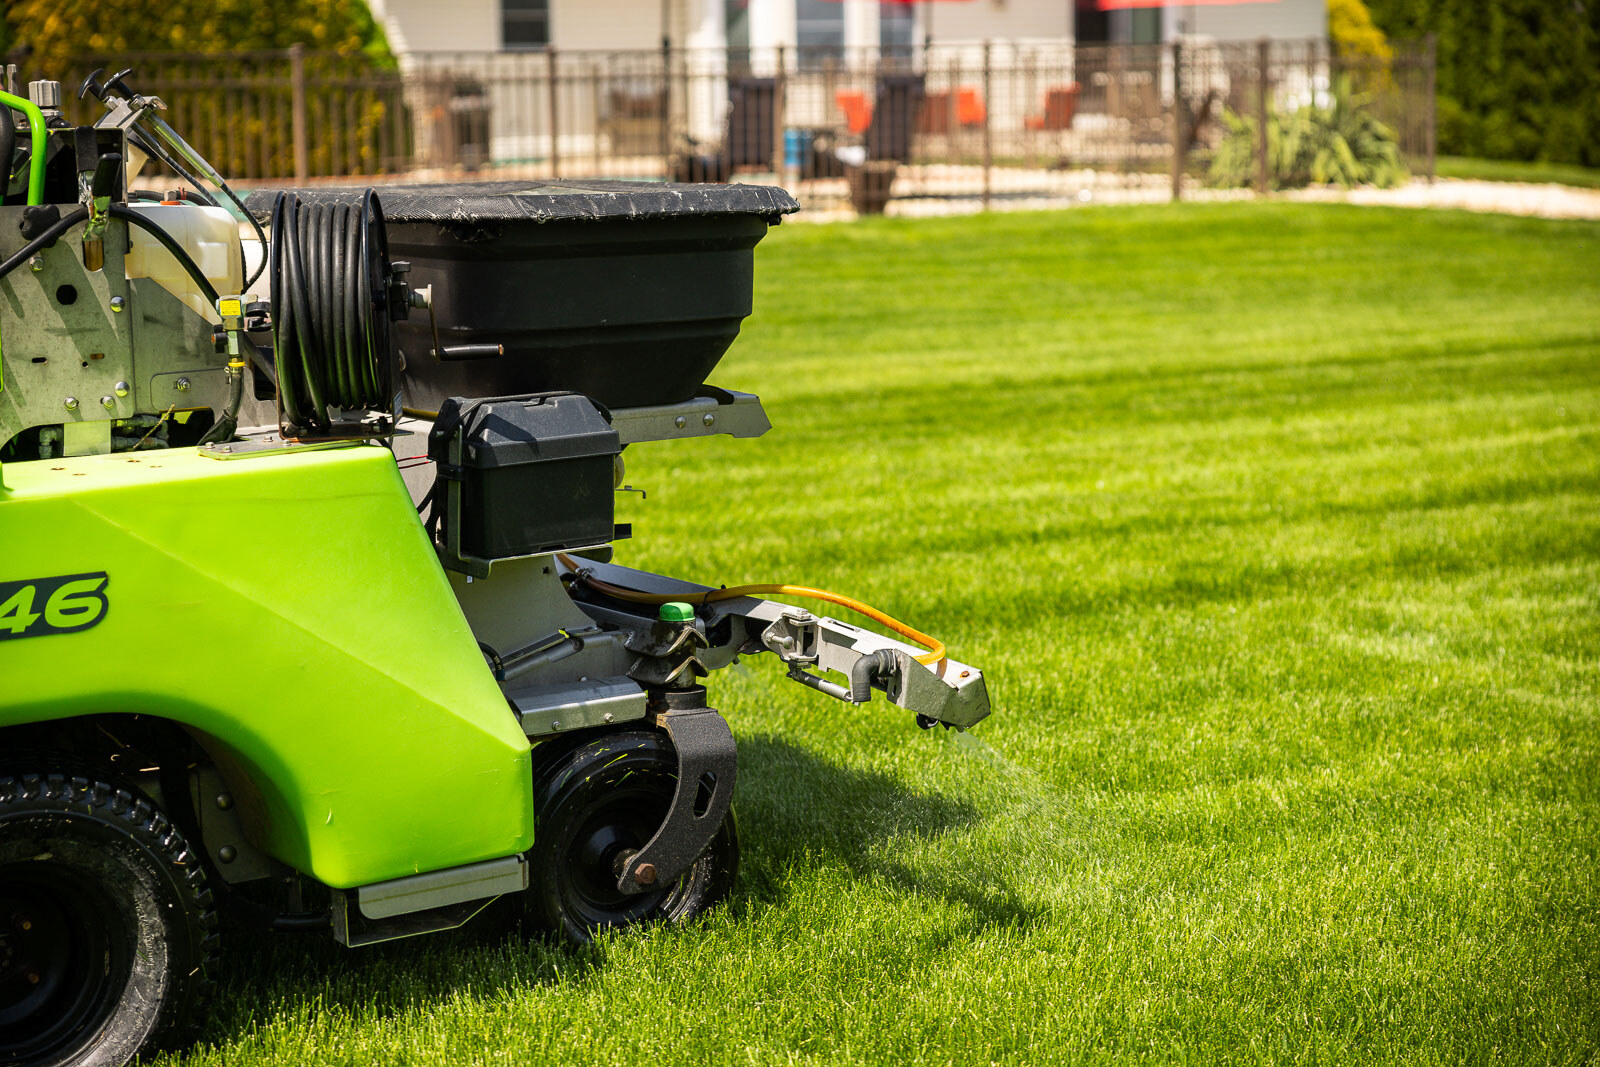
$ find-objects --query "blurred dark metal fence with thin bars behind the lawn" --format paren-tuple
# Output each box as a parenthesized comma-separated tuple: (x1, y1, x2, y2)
(67, 40, 1434, 211)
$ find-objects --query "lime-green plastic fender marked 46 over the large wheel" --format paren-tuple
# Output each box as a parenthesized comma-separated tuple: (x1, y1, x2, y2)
(0, 446, 533, 888)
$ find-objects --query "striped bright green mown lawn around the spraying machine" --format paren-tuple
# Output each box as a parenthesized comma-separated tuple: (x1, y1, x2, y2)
(173, 203, 1600, 1067)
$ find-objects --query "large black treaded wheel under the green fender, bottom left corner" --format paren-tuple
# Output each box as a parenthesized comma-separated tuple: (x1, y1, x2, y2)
(0, 774, 216, 1067)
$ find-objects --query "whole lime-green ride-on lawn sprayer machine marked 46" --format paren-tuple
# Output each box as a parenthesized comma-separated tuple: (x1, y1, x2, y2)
(0, 72, 989, 1064)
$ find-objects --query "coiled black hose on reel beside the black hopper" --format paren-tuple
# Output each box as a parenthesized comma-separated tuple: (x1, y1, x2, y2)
(270, 189, 394, 434)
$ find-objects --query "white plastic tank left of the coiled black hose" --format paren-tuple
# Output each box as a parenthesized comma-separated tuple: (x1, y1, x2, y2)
(123, 200, 245, 322)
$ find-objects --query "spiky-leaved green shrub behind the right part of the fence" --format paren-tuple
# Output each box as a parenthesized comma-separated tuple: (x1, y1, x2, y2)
(1206, 77, 1406, 189)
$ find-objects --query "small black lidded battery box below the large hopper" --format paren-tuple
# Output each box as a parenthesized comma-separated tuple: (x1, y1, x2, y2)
(427, 392, 622, 560)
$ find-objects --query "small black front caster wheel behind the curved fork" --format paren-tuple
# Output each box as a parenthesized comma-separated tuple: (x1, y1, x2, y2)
(528, 729, 739, 944)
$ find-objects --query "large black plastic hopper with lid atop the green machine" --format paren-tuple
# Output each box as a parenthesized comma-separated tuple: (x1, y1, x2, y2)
(250, 181, 798, 410)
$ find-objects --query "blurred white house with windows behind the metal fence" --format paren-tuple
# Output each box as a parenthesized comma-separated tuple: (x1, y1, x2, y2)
(370, 0, 1326, 168)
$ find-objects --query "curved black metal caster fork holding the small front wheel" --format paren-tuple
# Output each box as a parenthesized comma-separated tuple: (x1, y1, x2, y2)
(616, 686, 739, 893)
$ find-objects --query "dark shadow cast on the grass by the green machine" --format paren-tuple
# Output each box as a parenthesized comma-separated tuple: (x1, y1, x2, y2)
(190, 734, 1011, 1046)
